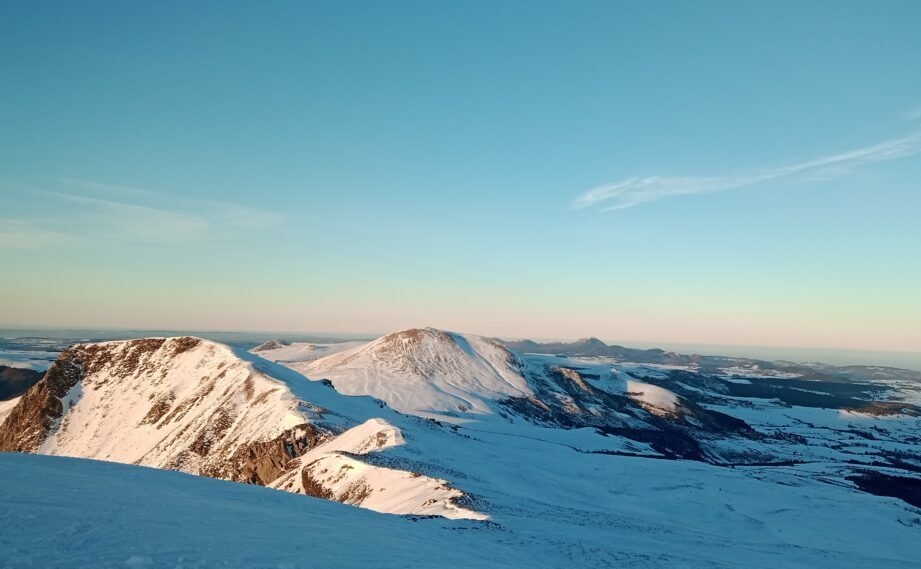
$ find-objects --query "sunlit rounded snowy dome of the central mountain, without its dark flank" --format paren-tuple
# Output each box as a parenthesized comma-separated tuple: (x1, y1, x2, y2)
(302, 328, 533, 421)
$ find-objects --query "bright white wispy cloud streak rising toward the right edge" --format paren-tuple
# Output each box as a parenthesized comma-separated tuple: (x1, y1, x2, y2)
(573, 132, 921, 211)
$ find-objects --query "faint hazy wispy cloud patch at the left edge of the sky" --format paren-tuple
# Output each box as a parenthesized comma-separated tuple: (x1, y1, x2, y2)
(0, 178, 285, 249)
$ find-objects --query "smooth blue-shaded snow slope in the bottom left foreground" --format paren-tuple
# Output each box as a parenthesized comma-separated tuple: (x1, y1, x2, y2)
(0, 453, 504, 569)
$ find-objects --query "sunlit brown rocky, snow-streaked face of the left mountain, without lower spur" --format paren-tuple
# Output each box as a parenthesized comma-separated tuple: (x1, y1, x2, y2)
(0, 337, 330, 485)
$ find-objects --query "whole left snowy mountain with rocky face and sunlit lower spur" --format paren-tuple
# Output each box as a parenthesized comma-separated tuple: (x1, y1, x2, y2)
(0, 337, 485, 518)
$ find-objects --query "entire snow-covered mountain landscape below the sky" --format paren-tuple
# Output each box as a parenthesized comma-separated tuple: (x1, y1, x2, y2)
(0, 328, 921, 569)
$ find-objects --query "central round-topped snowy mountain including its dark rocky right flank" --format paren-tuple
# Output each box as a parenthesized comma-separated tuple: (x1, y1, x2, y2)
(278, 328, 755, 459)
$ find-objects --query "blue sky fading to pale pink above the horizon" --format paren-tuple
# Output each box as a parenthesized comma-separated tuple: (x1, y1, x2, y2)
(0, 0, 921, 350)
